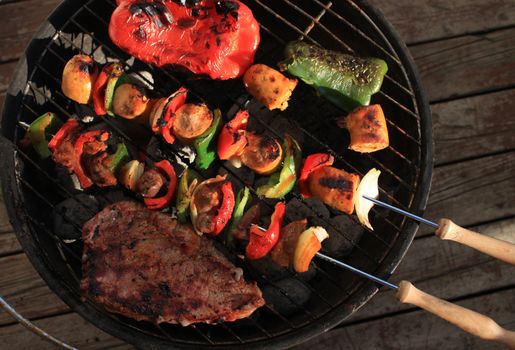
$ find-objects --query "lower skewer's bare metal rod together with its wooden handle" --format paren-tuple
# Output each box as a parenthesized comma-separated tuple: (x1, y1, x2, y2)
(254, 219, 515, 349)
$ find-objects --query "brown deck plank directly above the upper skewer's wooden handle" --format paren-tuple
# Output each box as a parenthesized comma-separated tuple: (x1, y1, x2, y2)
(417, 151, 515, 236)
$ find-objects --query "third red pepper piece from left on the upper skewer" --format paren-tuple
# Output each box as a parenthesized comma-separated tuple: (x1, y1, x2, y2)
(218, 110, 249, 160)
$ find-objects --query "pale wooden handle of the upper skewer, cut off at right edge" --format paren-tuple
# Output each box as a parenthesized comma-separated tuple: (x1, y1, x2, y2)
(435, 219, 515, 265)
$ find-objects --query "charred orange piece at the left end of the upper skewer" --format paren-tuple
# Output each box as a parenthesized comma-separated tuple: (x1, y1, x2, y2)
(61, 55, 98, 104)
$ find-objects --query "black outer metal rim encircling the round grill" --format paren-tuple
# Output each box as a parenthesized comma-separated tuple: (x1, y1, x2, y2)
(0, 0, 434, 349)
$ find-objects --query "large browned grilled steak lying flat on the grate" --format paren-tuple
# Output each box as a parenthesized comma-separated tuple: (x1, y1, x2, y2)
(81, 201, 264, 326)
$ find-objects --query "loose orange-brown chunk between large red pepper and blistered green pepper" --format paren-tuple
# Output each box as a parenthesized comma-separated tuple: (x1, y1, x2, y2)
(243, 64, 298, 111)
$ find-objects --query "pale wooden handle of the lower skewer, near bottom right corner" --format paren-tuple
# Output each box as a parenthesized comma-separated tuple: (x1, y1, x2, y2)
(396, 281, 515, 349)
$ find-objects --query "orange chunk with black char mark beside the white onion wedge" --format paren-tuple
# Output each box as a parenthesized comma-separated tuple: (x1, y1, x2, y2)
(308, 167, 359, 215)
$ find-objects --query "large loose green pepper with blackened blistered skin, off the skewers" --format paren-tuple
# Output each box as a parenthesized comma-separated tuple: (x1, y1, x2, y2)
(279, 41, 388, 111)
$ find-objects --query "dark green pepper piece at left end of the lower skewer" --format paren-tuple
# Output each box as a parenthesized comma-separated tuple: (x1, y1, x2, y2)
(27, 112, 63, 159)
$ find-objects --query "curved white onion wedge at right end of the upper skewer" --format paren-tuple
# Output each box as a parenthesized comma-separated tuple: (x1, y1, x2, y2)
(354, 168, 381, 231)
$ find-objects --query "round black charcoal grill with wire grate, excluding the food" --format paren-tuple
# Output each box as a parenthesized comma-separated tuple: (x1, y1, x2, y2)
(1, 0, 432, 349)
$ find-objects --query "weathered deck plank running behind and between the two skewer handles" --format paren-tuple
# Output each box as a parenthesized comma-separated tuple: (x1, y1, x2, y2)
(344, 219, 515, 324)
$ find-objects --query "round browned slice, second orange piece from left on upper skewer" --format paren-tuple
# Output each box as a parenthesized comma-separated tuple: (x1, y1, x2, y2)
(113, 83, 149, 119)
